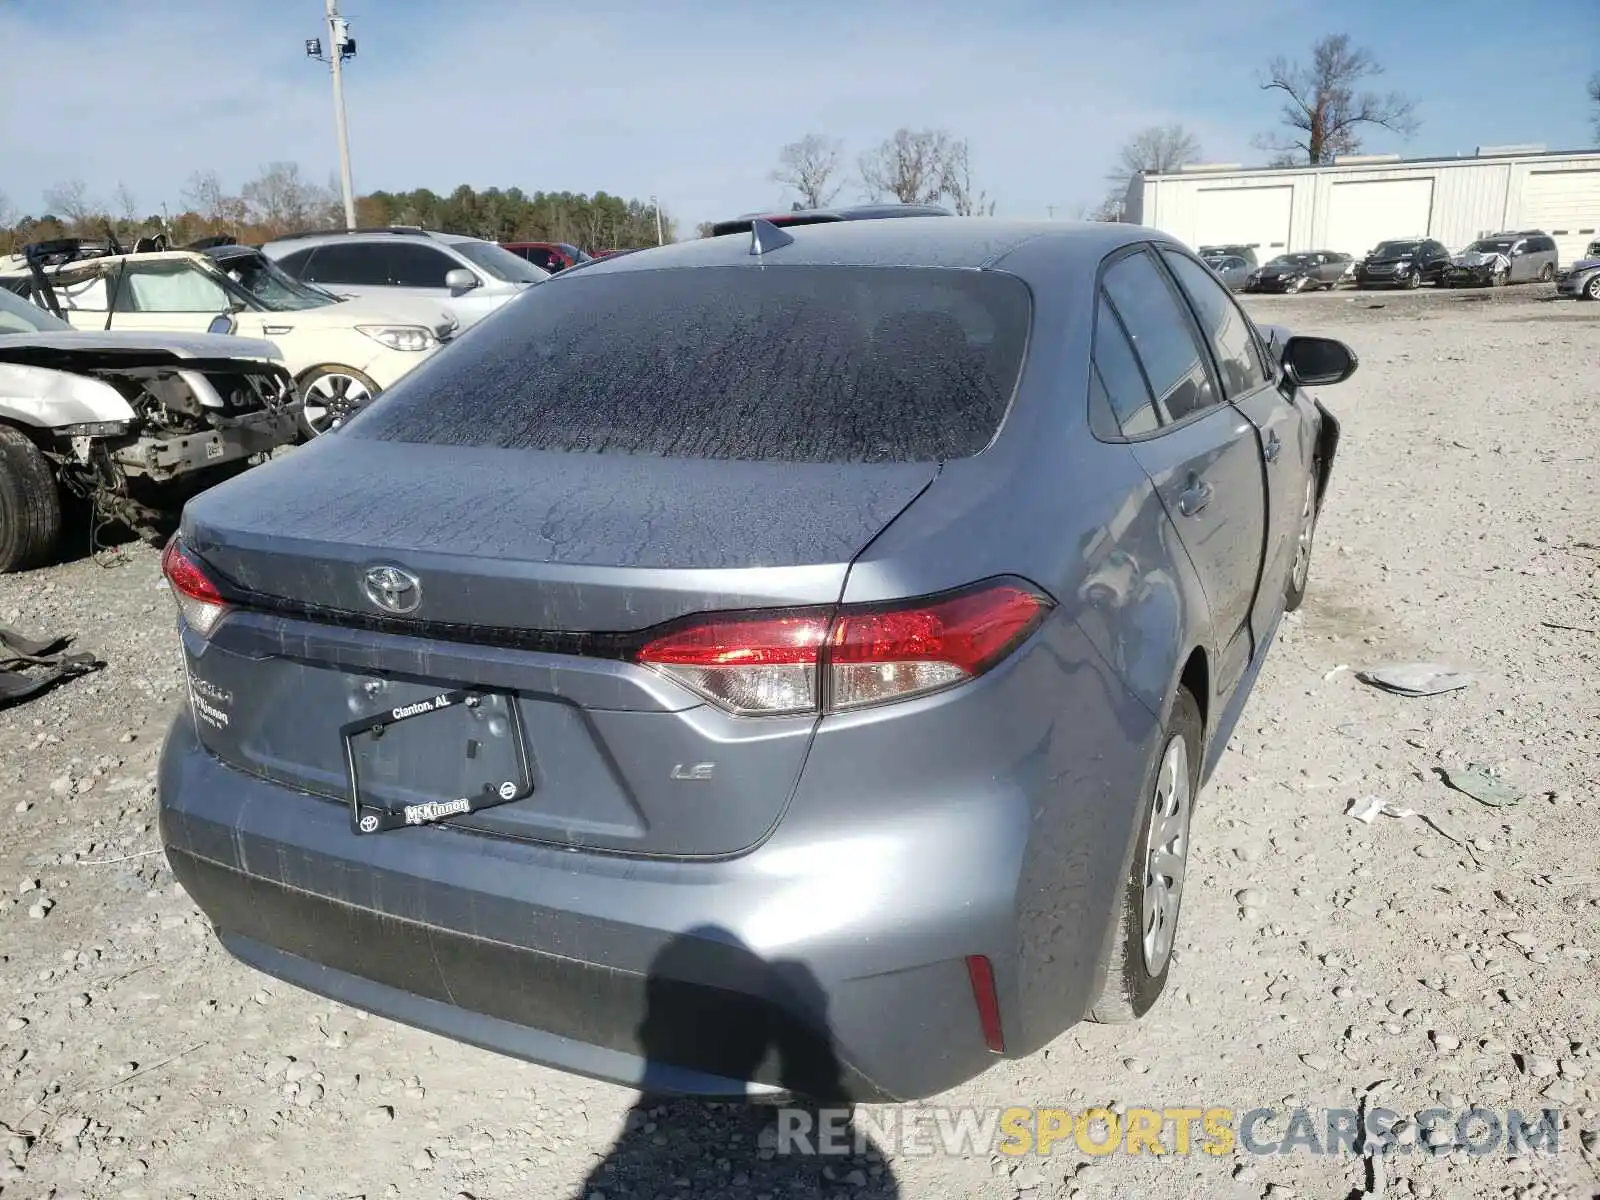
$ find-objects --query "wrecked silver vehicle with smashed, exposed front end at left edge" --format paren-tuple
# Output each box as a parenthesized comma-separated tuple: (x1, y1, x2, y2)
(0, 288, 301, 573)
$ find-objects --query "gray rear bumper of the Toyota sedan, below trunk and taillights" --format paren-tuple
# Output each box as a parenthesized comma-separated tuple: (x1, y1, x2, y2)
(158, 614, 1157, 1101)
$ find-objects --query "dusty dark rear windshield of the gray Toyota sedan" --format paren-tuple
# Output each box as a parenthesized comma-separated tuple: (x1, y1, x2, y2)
(346, 267, 1030, 462)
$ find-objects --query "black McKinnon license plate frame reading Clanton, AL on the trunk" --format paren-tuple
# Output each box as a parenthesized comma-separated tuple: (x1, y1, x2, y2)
(339, 690, 533, 834)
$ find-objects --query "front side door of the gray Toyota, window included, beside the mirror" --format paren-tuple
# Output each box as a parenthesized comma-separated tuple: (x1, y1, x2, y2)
(1162, 250, 1312, 643)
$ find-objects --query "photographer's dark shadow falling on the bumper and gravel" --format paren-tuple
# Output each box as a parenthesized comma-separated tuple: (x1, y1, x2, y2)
(574, 926, 901, 1200)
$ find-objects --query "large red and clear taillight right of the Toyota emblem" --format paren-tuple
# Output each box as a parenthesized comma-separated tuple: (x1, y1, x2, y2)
(638, 582, 1051, 717)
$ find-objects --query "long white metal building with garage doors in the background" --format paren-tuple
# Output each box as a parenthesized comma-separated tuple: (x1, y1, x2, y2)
(1125, 146, 1600, 262)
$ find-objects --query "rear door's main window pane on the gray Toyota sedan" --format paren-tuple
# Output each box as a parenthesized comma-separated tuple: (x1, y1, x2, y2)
(1104, 251, 1218, 422)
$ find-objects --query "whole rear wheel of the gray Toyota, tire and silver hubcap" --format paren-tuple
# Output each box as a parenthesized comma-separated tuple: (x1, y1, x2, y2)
(1090, 690, 1203, 1024)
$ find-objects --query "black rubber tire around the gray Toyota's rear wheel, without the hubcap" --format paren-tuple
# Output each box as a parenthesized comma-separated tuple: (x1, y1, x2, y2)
(1090, 688, 1205, 1026)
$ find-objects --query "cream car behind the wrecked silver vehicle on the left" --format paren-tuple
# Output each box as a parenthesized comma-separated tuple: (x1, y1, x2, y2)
(0, 238, 458, 438)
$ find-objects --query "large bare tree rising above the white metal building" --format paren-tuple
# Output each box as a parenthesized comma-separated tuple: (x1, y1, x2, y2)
(1256, 34, 1421, 165)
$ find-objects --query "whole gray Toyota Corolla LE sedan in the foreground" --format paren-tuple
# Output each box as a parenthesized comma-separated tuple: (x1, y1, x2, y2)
(160, 218, 1355, 1099)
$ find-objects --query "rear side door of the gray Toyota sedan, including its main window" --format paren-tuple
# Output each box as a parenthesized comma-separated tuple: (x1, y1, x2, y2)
(1102, 248, 1266, 696)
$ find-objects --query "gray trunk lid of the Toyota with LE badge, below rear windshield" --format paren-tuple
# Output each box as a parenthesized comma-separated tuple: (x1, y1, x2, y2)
(182, 434, 938, 856)
